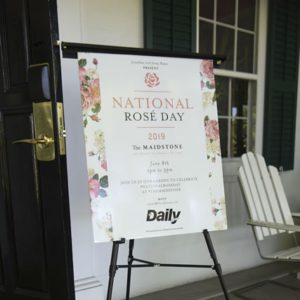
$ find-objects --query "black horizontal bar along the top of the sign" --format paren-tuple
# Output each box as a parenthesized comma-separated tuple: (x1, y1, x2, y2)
(61, 42, 225, 67)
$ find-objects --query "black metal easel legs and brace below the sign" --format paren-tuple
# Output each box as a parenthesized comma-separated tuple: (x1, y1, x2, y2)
(106, 229, 229, 300)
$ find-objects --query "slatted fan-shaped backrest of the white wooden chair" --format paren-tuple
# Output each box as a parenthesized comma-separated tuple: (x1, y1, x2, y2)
(239, 152, 294, 240)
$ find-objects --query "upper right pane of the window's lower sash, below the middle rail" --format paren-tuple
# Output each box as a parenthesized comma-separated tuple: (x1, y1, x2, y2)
(231, 79, 248, 118)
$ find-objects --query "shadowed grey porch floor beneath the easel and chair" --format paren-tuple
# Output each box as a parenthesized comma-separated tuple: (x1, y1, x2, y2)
(131, 262, 300, 300)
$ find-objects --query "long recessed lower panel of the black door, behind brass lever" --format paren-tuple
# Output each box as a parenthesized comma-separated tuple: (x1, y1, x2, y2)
(4, 111, 46, 290)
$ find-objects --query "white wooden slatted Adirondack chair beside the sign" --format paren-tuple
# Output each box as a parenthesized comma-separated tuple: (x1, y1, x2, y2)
(239, 152, 300, 262)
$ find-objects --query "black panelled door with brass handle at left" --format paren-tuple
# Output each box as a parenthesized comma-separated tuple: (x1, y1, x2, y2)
(0, 0, 74, 300)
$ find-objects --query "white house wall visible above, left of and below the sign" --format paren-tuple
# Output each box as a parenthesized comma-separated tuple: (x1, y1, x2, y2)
(58, 0, 300, 300)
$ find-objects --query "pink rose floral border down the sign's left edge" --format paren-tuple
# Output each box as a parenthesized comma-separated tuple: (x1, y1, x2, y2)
(78, 58, 112, 240)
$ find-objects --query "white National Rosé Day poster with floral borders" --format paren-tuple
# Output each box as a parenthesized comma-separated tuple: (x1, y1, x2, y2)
(78, 53, 226, 242)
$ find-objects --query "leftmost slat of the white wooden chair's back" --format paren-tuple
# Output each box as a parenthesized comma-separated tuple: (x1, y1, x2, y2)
(242, 154, 270, 236)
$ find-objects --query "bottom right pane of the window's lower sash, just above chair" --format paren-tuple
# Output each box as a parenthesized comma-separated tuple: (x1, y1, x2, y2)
(230, 119, 247, 157)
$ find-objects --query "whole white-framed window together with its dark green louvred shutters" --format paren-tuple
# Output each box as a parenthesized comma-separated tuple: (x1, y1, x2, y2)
(144, 0, 300, 170)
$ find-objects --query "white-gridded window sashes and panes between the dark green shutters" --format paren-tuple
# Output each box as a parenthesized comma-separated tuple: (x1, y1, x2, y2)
(197, 0, 257, 157)
